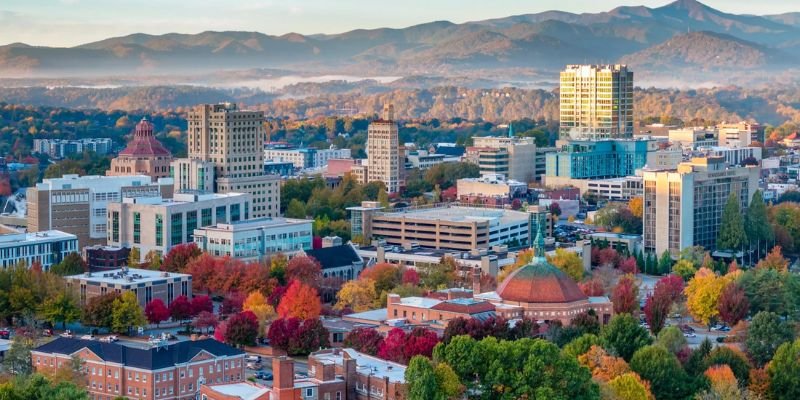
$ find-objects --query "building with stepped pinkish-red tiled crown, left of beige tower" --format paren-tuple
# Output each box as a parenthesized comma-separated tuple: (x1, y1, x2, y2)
(106, 118, 172, 179)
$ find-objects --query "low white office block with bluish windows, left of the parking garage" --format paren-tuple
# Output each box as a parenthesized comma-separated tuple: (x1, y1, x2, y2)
(194, 218, 313, 261)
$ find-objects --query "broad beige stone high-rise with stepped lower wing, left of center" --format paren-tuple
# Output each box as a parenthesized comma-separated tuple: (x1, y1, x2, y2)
(188, 103, 281, 218)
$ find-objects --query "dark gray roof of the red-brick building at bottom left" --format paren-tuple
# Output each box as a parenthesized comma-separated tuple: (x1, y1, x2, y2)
(35, 337, 244, 370)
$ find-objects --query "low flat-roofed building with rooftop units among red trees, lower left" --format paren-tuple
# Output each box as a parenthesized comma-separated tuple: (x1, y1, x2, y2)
(64, 267, 192, 308)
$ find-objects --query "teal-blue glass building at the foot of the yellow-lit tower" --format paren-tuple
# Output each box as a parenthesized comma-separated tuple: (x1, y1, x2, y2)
(545, 139, 656, 179)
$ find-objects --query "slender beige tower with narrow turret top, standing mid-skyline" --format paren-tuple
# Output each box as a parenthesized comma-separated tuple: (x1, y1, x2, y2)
(366, 104, 405, 193)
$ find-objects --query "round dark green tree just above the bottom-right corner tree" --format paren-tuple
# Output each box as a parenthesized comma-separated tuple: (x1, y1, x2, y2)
(745, 311, 793, 366)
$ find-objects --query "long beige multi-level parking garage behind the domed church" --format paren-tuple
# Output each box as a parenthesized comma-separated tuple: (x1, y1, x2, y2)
(361, 205, 528, 251)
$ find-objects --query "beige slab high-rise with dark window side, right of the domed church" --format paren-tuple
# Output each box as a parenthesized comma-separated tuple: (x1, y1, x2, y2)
(642, 156, 760, 256)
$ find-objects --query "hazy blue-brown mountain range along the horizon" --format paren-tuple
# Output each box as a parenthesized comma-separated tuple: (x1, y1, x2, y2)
(0, 0, 800, 84)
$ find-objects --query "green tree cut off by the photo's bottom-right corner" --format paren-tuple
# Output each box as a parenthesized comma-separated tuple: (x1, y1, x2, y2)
(767, 339, 800, 400)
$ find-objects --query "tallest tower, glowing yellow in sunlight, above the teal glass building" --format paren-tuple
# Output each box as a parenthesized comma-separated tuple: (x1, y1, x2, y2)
(559, 65, 633, 139)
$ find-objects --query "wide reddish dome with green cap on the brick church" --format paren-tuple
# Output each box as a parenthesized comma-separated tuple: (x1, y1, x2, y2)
(497, 260, 588, 303)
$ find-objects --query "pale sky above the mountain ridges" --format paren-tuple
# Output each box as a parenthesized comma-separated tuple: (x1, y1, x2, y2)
(0, 0, 800, 47)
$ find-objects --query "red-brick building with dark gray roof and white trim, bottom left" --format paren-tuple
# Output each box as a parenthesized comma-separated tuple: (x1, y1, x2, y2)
(31, 337, 245, 400)
